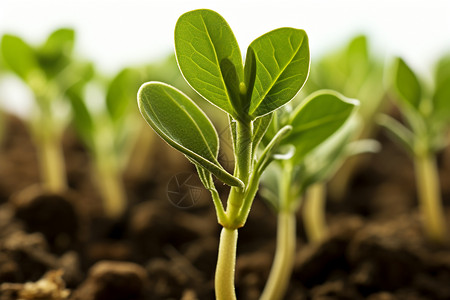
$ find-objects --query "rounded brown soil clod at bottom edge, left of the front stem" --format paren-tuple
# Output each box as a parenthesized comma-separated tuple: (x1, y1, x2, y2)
(70, 261, 148, 300)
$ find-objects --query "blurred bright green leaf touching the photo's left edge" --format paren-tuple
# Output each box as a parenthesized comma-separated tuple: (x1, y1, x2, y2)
(1, 34, 39, 81)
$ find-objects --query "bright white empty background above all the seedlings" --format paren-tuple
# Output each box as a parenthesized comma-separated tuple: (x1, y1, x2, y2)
(0, 0, 450, 114)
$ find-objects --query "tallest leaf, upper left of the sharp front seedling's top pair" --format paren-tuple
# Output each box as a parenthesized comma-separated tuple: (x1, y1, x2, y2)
(175, 9, 244, 118)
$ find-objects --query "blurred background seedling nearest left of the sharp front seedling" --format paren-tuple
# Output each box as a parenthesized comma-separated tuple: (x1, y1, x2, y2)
(69, 69, 140, 219)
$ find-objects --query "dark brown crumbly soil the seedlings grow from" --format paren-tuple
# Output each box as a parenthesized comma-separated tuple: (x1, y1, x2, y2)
(0, 112, 450, 300)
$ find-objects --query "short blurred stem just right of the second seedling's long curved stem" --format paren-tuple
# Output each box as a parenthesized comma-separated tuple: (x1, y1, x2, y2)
(303, 182, 327, 242)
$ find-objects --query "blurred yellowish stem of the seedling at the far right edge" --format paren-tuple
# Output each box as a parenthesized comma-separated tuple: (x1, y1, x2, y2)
(414, 152, 447, 244)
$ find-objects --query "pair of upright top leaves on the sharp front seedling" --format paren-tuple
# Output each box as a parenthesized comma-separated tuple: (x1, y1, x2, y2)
(175, 10, 309, 120)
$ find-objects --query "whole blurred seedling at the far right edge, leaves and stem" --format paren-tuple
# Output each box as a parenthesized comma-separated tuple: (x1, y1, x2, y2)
(379, 58, 450, 244)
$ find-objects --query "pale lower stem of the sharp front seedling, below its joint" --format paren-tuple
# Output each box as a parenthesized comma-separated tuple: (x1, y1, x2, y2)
(215, 228, 238, 300)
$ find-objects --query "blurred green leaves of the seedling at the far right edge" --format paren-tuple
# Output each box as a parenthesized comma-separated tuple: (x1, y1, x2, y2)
(379, 58, 450, 155)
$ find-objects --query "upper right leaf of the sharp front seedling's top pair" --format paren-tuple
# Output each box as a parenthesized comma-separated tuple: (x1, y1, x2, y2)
(246, 28, 310, 118)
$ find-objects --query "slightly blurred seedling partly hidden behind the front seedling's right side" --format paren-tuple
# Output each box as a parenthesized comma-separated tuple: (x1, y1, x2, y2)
(261, 91, 358, 300)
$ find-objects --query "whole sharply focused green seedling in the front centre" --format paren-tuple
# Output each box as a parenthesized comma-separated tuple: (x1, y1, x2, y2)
(138, 9, 309, 299)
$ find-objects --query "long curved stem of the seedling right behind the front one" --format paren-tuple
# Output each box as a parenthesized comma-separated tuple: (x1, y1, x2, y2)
(260, 163, 297, 300)
